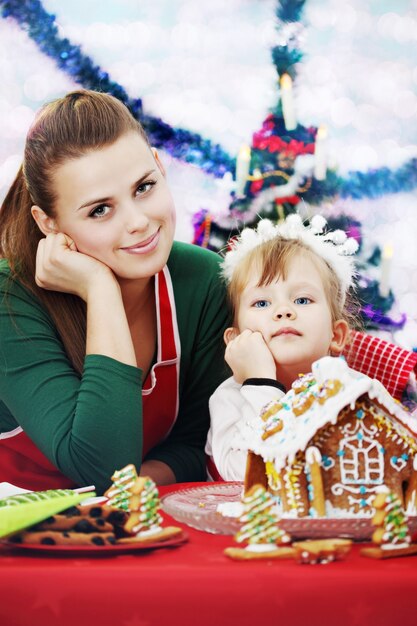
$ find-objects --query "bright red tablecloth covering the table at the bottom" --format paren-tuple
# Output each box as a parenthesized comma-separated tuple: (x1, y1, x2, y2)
(0, 485, 417, 626)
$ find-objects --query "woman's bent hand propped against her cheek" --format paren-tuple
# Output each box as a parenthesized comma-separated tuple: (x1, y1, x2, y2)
(35, 233, 116, 301)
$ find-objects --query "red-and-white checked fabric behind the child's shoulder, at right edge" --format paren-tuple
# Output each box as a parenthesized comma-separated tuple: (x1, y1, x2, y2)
(343, 331, 417, 400)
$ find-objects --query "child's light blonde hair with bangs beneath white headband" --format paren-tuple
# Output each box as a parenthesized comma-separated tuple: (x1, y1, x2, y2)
(228, 237, 358, 328)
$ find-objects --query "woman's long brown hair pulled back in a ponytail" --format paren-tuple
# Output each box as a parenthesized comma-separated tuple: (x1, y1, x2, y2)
(0, 89, 148, 373)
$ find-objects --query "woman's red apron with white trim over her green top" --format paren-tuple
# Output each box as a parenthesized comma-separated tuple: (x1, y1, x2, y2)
(0, 267, 180, 490)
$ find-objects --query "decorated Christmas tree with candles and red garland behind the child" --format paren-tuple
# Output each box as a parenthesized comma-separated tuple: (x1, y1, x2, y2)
(193, 0, 406, 331)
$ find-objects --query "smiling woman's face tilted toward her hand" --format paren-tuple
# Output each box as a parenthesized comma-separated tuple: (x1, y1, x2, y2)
(48, 132, 175, 279)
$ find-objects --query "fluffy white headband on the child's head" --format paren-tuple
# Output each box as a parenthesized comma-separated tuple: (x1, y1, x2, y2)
(222, 213, 359, 293)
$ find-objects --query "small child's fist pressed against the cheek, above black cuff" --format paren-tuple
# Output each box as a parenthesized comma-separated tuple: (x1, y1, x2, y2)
(225, 330, 276, 383)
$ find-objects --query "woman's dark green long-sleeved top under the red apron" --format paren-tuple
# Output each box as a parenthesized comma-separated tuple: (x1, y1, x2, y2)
(0, 242, 229, 492)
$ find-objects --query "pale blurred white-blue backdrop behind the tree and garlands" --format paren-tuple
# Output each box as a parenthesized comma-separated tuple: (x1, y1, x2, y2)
(0, 0, 417, 348)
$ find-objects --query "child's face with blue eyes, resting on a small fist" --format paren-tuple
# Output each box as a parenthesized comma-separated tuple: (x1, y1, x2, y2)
(237, 255, 348, 384)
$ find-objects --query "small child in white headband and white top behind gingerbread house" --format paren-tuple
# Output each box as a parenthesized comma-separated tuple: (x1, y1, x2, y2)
(206, 215, 357, 480)
